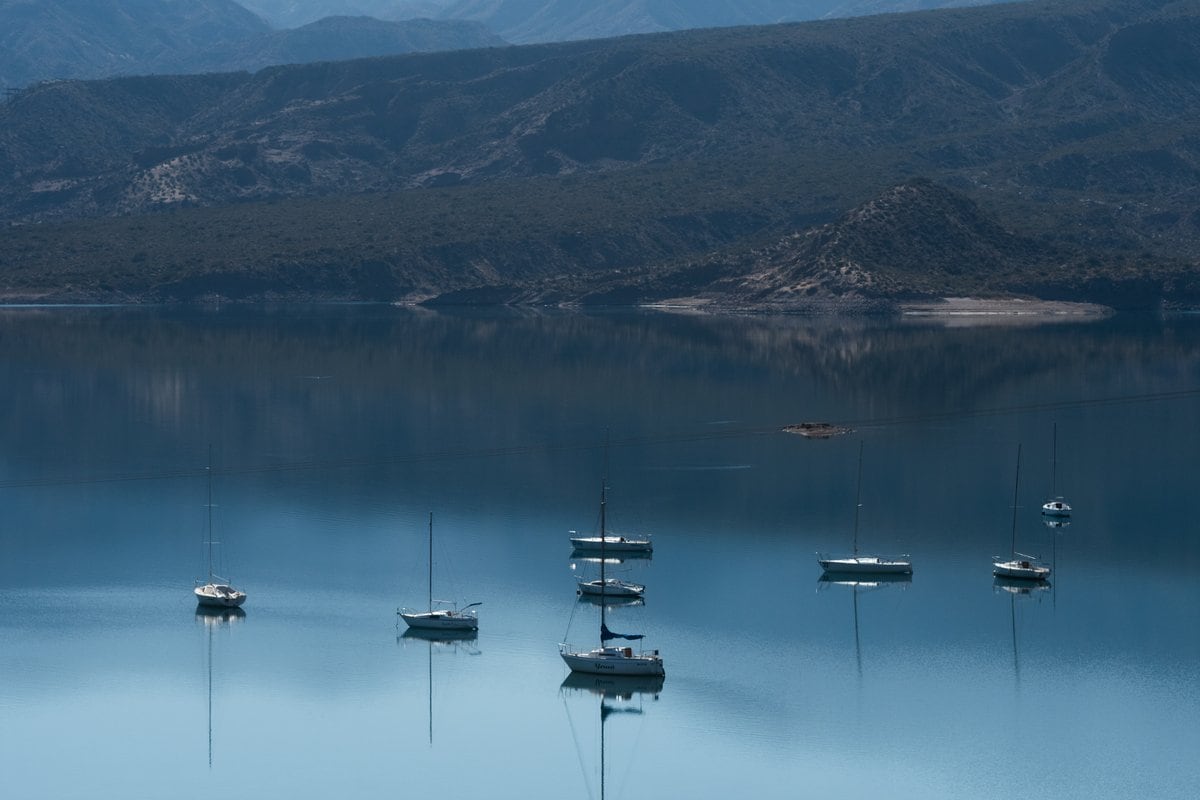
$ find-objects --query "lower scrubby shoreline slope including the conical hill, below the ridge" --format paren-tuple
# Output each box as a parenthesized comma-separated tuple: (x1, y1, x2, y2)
(0, 173, 1200, 313)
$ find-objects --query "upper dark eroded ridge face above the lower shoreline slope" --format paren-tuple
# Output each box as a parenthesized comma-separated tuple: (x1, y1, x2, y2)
(0, 0, 1200, 219)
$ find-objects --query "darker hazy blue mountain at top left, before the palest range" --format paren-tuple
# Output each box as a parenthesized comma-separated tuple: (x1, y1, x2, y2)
(0, 0, 505, 88)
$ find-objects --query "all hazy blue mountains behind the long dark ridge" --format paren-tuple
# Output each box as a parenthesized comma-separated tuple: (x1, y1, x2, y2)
(0, 0, 1012, 90)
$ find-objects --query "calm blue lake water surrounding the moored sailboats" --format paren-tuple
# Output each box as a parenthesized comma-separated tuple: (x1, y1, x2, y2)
(0, 307, 1200, 799)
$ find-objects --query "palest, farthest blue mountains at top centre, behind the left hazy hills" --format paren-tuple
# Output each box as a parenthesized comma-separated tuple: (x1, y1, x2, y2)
(242, 0, 1001, 44)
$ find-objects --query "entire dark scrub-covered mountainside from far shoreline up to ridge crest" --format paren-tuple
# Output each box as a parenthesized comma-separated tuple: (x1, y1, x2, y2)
(0, 0, 1200, 309)
